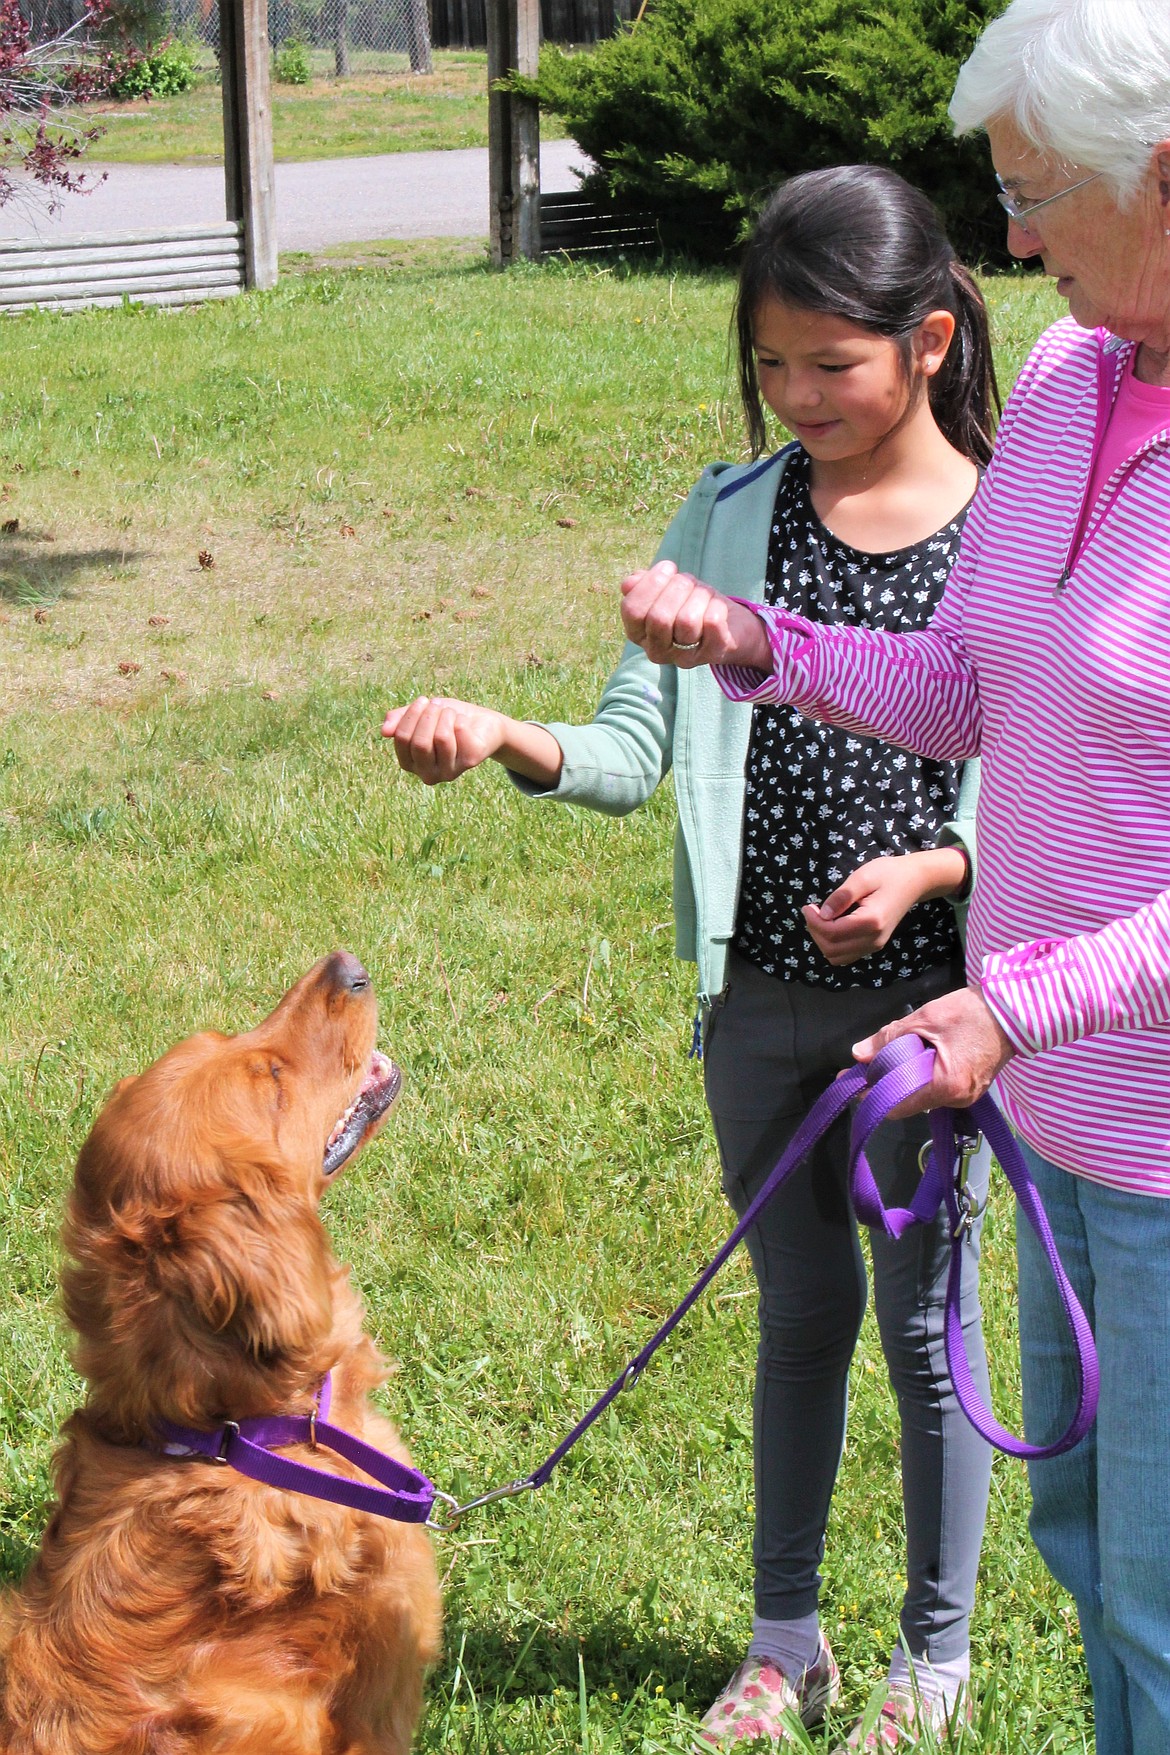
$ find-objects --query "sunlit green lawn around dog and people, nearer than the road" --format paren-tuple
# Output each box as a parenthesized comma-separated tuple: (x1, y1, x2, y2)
(0, 256, 1093, 1755)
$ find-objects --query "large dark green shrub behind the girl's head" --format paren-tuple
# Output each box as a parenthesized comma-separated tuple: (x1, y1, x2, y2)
(512, 0, 1005, 261)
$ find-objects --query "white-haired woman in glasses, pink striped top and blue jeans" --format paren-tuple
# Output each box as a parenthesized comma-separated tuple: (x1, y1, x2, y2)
(623, 0, 1170, 1755)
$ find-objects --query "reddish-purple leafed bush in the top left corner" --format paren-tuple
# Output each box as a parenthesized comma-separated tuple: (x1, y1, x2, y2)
(0, 0, 114, 211)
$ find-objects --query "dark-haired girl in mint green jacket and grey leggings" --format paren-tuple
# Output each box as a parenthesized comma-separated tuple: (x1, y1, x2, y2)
(382, 165, 996, 1748)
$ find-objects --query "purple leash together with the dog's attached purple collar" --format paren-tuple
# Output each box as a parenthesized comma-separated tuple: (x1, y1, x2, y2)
(158, 1035, 1100, 1532)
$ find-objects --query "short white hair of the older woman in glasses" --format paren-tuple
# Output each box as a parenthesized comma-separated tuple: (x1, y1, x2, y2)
(951, 0, 1170, 202)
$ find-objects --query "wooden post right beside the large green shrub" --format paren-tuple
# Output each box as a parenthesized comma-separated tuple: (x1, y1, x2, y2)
(488, 0, 540, 269)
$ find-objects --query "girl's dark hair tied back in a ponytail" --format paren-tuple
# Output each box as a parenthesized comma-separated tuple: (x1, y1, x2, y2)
(733, 165, 1000, 463)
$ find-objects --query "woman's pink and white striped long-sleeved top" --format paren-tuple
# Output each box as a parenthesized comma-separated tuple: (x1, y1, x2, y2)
(716, 318, 1170, 1195)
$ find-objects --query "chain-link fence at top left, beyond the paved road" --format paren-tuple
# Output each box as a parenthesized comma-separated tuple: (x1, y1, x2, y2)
(164, 0, 432, 79)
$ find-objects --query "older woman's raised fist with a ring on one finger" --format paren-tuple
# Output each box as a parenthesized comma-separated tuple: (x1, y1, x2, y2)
(621, 560, 772, 670)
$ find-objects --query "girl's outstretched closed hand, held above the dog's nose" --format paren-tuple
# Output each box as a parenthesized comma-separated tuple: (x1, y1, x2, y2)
(382, 695, 561, 786)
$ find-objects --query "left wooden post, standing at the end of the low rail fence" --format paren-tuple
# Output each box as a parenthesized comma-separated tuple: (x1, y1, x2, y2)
(219, 0, 277, 286)
